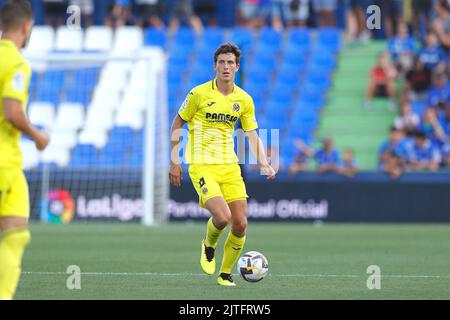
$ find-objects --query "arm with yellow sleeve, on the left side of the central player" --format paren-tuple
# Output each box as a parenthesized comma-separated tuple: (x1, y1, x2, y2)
(169, 91, 199, 187)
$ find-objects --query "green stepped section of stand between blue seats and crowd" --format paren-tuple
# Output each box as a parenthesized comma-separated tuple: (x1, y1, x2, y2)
(316, 41, 395, 169)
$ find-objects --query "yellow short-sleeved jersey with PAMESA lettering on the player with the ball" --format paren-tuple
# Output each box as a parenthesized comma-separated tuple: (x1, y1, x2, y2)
(178, 79, 258, 164)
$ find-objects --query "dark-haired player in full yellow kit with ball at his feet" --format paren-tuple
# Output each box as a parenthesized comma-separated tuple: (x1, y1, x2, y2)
(169, 44, 275, 286)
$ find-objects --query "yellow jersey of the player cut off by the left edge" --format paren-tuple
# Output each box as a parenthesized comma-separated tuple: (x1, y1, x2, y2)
(0, 40, 31, 169)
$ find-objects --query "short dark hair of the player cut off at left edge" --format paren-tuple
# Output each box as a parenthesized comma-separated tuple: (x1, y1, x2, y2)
(0, 0, 33, 31)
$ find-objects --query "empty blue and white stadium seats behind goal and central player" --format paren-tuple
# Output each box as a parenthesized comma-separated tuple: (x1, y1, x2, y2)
(22, 26, 342, 169)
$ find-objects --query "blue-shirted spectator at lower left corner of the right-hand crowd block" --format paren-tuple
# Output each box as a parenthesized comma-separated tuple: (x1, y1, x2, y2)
(378, 127, 408, 178)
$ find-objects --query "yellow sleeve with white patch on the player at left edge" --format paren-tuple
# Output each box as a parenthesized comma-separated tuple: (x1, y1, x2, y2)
(1, 62, 31, 107)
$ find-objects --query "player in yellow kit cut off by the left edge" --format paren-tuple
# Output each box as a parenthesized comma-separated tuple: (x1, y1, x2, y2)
(0, 0, 49, 300)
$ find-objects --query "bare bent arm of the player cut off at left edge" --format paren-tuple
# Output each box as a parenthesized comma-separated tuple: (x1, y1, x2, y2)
(3, 98, 50, 150)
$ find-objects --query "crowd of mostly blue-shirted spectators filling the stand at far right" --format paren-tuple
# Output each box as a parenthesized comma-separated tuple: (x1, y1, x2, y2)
(366, 0, 450, 177)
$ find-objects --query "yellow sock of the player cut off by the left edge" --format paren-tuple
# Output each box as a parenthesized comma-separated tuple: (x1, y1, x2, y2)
(0, 229, 30, 300)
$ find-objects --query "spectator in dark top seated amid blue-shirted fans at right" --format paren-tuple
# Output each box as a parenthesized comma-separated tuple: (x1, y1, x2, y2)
(403, 59, 431, 102)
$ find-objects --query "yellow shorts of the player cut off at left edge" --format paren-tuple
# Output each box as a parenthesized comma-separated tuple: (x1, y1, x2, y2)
(0, 168, 30, 219)
